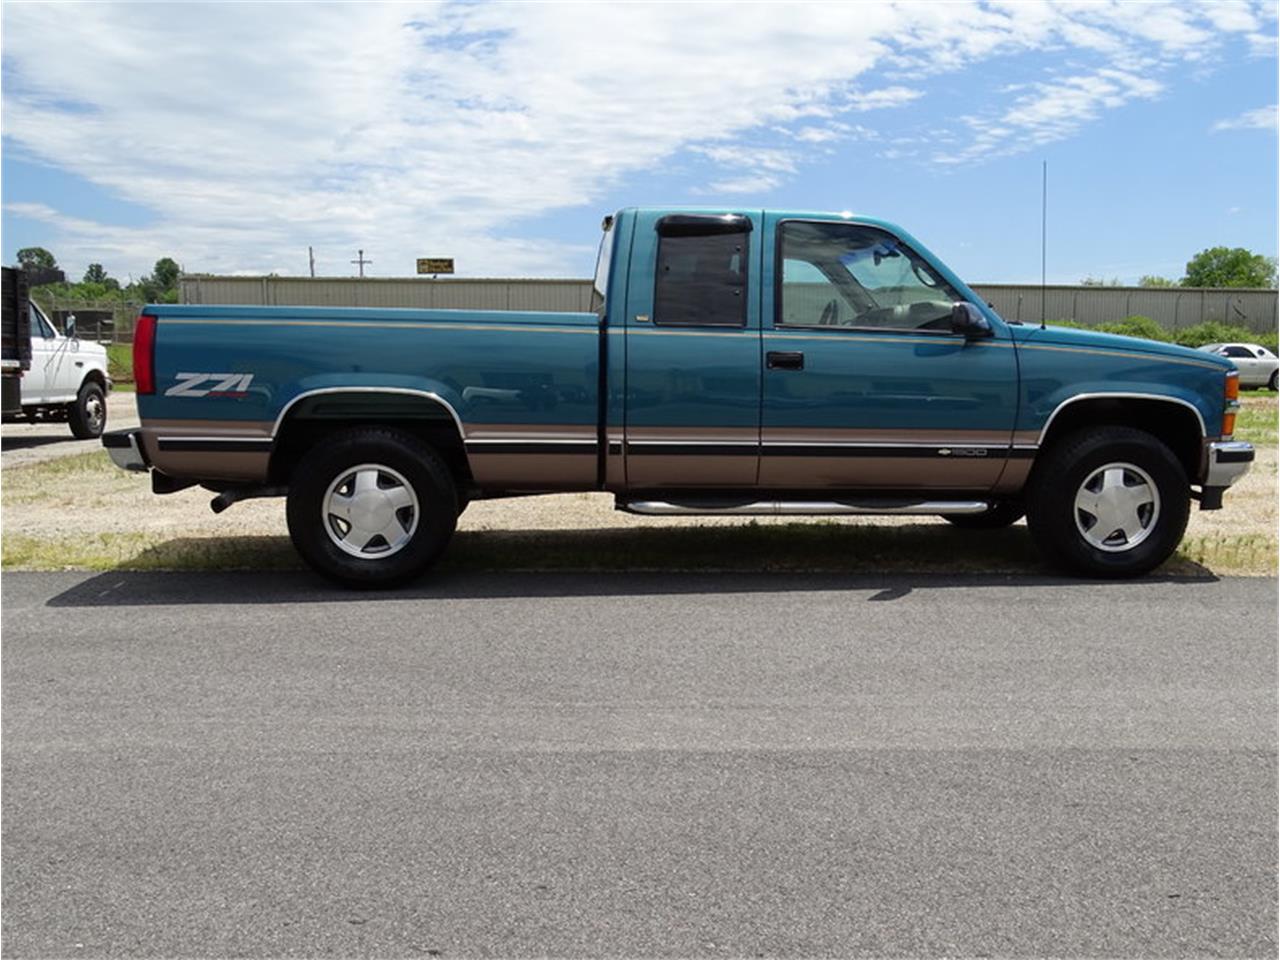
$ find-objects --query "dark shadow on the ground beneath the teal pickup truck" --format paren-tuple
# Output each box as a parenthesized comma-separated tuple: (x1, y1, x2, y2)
(40, 524, 1217, 607)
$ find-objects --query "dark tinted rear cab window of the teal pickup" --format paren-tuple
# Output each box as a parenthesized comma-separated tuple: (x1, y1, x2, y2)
(653, 216, 751, 326)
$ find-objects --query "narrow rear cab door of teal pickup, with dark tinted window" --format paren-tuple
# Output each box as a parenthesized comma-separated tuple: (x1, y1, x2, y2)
(623, 211, 762, 490)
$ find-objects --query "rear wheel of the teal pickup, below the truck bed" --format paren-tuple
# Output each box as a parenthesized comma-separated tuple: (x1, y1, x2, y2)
(285, 428, 458, 588)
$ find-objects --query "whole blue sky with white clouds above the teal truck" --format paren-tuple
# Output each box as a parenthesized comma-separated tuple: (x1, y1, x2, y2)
(0, 0, 1280, 283)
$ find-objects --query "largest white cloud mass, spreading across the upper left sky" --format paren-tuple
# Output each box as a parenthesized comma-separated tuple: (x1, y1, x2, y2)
(3, 3, 1274, 275)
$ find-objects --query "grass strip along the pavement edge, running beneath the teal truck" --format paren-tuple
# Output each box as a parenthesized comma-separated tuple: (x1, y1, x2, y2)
(3, 524, 1276, 576)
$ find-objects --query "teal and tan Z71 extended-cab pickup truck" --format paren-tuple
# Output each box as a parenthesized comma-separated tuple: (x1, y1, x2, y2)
(102, 209, 1253, 586)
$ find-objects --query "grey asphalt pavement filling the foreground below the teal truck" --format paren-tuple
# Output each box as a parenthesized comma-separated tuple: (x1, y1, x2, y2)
(0, 573, 1277, 957)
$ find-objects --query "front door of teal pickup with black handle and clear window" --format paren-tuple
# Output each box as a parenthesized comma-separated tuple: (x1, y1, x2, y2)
(760, 215, 1024, 492)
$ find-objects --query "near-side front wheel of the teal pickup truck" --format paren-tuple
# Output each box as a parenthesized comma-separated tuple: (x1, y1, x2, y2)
(1027, 426, 1190, 579)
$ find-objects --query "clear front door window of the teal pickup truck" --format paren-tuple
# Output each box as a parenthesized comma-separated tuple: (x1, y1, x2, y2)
(776, 221, 963, 332)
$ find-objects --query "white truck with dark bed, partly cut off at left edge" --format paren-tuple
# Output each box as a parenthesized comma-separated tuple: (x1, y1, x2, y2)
(3, 268, 111, 440)
